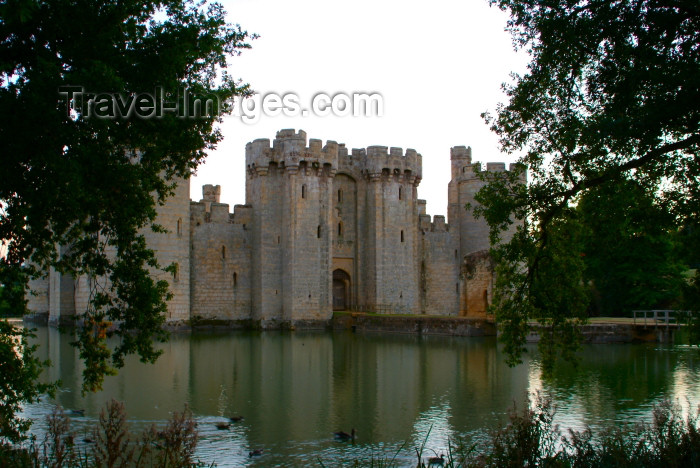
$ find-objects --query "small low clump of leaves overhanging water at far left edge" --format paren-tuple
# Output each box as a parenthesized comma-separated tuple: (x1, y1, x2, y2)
(0, 320, 55, 444)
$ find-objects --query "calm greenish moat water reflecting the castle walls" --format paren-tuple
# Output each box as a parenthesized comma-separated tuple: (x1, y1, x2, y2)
(19, 327, 700, 466)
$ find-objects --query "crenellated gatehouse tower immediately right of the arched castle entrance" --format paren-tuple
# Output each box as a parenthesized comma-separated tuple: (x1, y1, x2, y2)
(360, 146, 422, 313)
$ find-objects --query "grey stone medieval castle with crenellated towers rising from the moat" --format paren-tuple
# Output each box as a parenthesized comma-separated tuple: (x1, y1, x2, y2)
(29, 130, 525, 328)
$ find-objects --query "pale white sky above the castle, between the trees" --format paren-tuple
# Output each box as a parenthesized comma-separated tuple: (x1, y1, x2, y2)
(191, 0, 527, 215)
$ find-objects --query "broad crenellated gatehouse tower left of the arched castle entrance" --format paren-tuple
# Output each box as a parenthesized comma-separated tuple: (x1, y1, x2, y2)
(246, 130, 338, 326)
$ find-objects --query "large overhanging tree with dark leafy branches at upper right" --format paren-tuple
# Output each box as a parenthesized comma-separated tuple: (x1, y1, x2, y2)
(477, 0, 700, 372)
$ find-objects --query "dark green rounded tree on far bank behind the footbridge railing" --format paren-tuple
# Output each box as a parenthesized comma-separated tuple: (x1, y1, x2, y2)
(578, 179, 686, 316)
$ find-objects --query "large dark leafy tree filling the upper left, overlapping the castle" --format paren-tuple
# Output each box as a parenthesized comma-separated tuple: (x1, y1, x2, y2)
(0, 0, 254, 436)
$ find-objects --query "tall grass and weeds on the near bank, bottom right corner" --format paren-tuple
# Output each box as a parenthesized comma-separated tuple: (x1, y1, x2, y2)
(444, 396, 700, 468)
